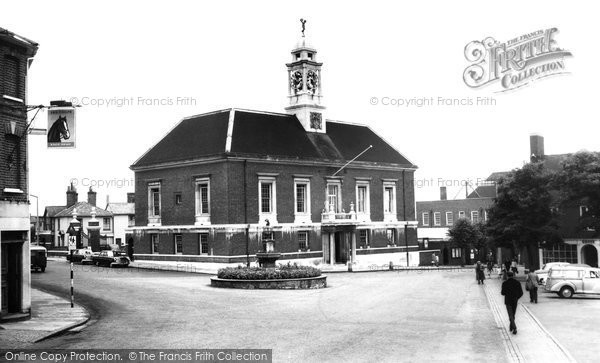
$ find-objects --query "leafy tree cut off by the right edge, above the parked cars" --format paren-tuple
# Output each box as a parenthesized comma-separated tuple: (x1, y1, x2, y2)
(554, 151, 600, 232)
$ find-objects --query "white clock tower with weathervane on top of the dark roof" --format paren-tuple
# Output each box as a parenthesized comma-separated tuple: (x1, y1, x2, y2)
(285, 19, 326, 133)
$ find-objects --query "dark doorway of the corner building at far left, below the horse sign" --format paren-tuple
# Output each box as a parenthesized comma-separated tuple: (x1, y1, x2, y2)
(0, 243, 23, 315)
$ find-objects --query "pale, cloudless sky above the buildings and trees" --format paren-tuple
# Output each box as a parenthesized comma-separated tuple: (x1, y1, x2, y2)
(0, 0, 600, 214)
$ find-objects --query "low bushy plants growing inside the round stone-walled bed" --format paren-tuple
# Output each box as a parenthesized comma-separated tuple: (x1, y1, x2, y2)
(217, 263, 321, 280)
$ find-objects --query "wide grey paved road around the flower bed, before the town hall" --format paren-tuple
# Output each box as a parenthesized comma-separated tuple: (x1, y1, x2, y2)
(32, 261, 506, 362)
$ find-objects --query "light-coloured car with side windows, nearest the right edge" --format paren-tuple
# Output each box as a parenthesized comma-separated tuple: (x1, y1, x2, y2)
(545, 265, 600, 298)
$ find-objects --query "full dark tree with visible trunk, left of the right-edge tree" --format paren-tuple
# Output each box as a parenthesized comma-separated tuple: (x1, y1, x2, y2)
(485, 162, 562, 266)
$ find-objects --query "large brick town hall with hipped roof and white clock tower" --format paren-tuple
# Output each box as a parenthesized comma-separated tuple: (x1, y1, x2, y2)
(127, 29, 418, 264)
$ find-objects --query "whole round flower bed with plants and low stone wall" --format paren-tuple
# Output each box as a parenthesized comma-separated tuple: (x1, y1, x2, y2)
(210, 263, 327, 289)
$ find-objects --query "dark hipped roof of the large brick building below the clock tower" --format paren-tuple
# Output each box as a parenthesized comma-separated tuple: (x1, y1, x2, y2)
(131, 108, 416, 170)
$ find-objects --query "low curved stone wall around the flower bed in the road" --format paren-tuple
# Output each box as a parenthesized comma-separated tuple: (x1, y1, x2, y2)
(210, 275, 327, 290)
